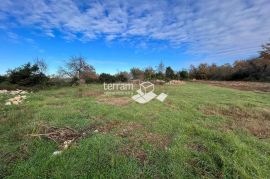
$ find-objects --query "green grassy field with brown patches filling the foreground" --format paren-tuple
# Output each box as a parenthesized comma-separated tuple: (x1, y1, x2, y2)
(0, 83, 270, 178)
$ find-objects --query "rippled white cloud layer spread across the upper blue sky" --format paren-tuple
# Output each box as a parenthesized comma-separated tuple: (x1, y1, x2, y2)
(0, 0, 270, 60)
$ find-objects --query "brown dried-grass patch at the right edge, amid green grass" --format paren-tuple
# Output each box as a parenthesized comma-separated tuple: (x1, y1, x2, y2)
(201, 106, 270, 138)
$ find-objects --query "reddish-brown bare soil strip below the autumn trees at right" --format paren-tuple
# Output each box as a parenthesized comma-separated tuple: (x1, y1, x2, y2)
(195, 80, 270, 92)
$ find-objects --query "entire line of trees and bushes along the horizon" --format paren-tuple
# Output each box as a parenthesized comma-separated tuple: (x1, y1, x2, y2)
(0, 43, 270, 89)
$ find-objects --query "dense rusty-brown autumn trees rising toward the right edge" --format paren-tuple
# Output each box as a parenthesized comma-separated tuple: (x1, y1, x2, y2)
(189, 43, 270, 81)
